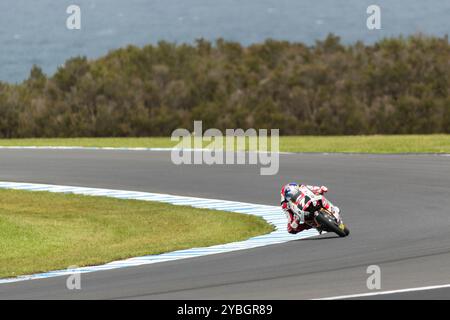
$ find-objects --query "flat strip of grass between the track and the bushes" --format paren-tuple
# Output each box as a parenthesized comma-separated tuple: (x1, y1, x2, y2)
(0, 134, 450, 153)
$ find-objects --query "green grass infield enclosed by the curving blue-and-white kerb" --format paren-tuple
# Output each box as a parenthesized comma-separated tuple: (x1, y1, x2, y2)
(0, 190, 273, 278)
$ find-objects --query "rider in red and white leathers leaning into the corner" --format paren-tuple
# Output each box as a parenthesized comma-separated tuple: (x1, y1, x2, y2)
(281, 182, 339, 234)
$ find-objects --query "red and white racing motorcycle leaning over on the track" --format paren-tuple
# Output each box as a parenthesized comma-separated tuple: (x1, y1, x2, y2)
(294, 192, 350, 237)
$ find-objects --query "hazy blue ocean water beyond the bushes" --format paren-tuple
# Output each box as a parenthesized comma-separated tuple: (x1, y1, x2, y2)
(0, 0, 450, 82)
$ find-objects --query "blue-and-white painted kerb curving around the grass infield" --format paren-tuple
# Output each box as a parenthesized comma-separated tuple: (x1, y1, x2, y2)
(0, 181, 318, 284)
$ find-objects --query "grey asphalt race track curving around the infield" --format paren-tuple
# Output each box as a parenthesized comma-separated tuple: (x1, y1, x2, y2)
(0, 150, 450, 299)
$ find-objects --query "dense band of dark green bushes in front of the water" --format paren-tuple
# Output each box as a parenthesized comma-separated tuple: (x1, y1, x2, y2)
(0, 35, 450, 138)
